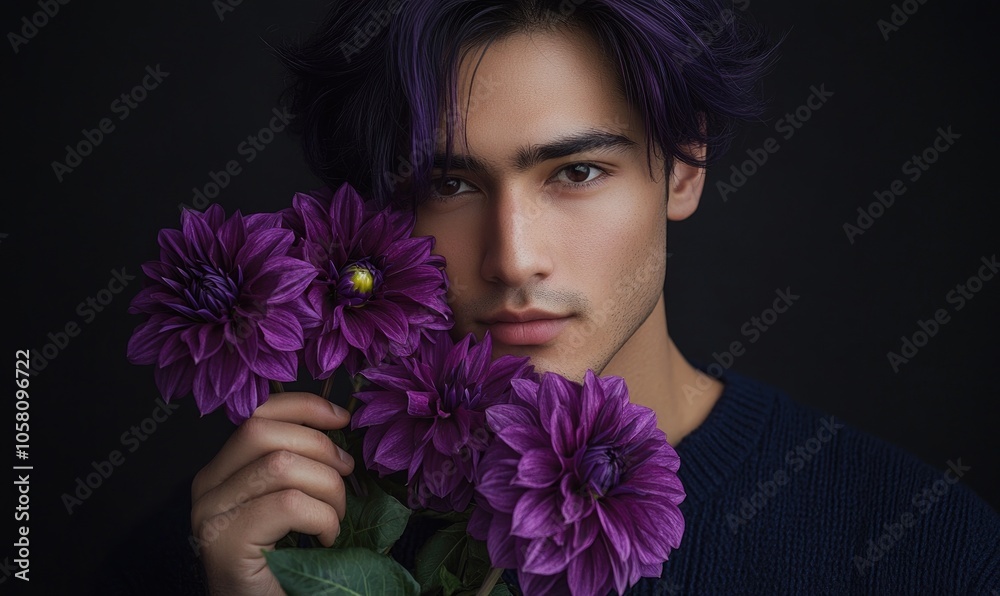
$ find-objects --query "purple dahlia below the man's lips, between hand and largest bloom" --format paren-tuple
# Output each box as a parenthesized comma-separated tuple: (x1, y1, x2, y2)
(351, 331, 534, 511)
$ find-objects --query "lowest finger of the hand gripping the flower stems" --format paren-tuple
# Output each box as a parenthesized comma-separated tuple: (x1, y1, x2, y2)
(195, 489, 340, 565)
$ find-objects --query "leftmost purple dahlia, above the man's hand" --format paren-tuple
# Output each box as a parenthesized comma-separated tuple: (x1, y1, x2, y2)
(128, 205, 314, 424)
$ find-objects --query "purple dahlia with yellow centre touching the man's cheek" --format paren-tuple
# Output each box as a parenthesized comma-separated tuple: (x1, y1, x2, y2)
(284, 183, 453, 379)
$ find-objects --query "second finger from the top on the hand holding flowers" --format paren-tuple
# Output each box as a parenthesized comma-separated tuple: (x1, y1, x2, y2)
(191, 416, 354, 502)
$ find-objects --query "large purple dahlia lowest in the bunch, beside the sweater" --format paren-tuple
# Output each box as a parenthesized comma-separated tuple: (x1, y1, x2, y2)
(469, 371, 685, 594)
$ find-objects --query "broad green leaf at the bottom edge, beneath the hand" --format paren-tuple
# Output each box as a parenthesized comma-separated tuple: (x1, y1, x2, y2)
(264, 548, 420, 596)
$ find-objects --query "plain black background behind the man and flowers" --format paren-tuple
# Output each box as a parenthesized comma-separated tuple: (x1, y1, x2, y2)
(0, 0, 1000, 593)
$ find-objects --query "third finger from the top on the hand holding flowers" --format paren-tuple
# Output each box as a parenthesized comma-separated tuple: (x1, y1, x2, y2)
(191, 451, 347, 528)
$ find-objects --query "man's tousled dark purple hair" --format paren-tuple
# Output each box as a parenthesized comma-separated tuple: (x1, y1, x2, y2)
(276, 0, 774, 204)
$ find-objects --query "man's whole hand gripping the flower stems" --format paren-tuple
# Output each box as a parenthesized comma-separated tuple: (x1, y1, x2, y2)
(191, 393, 354, 594)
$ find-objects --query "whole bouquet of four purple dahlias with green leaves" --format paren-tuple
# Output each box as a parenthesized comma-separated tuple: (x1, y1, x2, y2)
(128, 184, 684, 596)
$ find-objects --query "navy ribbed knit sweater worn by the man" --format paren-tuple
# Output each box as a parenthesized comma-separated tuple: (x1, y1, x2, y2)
(101, 362, 1000, 595)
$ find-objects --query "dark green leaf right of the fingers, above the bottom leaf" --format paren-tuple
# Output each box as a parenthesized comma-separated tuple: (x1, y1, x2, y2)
(333, 480, 411, 552)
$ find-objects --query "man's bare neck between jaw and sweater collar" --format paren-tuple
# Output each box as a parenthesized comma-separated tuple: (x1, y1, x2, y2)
(601, 294, 724, 446)
